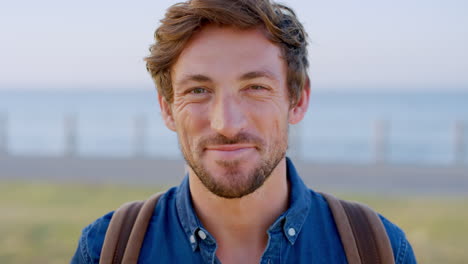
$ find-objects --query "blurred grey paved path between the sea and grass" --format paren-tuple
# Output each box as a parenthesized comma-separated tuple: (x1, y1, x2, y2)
(0, 156, 468, 195)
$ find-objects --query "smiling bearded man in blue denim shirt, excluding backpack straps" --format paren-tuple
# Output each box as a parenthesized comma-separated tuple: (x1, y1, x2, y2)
(72, 0, 415, 263)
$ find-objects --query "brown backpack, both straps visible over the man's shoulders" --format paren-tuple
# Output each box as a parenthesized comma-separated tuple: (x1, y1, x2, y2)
(99, 193, 394, 264)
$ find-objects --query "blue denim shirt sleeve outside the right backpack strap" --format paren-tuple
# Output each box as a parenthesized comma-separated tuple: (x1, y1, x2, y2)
(380, 216, 417, 264)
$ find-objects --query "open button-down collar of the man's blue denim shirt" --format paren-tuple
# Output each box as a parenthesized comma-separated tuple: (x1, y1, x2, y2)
(176, 158, 311, 251)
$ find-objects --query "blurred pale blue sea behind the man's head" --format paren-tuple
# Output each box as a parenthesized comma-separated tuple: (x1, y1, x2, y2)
(0, 89, 468, 165)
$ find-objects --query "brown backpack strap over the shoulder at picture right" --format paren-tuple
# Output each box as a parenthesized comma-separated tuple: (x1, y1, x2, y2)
(321, 193, 395, 264)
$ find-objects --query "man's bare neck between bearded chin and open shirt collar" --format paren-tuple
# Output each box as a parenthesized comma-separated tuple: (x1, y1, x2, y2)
(189, 159, 289, 263)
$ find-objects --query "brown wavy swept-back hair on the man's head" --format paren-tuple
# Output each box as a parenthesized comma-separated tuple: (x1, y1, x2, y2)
(145, 0, 309, 105)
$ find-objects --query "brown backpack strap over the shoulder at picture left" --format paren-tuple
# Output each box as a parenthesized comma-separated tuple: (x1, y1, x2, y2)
(99, 192, 163, 264)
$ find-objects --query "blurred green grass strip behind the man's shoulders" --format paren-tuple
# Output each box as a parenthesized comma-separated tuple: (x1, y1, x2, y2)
(0, 182, 468, 264)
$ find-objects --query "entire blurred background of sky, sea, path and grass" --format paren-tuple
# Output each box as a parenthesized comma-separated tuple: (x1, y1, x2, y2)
(0, 0, 468, 263)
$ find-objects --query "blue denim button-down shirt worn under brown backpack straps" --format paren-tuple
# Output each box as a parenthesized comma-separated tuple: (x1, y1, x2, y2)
(71, 159, 416, 264)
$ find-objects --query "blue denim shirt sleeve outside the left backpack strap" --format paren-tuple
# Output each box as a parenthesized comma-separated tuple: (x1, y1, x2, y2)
(70, 212, 114, 264)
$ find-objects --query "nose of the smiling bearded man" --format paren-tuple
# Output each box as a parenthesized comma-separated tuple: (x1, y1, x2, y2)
(211, 95, 247, 138)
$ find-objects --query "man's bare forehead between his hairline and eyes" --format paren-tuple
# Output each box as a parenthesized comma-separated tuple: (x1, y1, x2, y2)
(171, 26, 286, 82)
